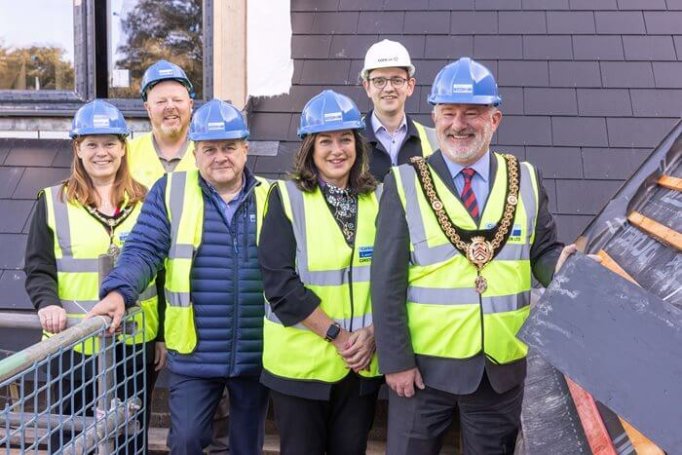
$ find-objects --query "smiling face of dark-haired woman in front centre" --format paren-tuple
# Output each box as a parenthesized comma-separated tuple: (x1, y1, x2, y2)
(313, 130, 356, 188)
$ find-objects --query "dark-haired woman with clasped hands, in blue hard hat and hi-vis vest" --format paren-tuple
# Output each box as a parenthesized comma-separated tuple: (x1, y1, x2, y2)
(259, 90, 382, 455)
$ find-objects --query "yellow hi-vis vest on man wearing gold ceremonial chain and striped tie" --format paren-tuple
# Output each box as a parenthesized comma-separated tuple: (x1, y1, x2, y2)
(392, 154, 538, 364)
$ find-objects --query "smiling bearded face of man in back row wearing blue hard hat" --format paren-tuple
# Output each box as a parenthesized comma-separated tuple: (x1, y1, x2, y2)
(144, 80, 193, 139)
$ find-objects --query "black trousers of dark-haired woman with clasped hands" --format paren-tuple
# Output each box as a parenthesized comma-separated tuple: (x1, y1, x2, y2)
(270, 373, 378, 455)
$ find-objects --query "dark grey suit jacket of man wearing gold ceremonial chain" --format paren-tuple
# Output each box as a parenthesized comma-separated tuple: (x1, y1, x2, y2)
(371, 150, 563, 394)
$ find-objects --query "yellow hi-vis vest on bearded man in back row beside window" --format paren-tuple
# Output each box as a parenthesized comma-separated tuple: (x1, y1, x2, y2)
(127, 133, 196, 188)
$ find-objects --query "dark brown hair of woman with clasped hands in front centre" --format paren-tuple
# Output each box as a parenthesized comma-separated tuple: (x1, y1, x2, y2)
(291, 130, 377, 194)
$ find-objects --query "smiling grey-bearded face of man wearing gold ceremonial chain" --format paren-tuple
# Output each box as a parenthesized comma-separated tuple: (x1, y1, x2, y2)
(432, 104, 502, 166)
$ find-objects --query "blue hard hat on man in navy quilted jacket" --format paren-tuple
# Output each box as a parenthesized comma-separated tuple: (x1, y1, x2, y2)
(189, 99, 249, 141)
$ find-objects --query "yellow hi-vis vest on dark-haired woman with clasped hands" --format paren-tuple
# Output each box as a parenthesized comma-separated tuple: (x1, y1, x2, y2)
(263, 181, 379, 383)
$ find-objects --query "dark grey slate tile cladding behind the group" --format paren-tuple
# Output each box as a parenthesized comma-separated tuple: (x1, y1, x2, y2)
(250, 0, 682, 246)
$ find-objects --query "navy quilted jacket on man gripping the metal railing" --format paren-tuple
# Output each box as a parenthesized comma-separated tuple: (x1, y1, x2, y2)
(101, 169, 264, 378)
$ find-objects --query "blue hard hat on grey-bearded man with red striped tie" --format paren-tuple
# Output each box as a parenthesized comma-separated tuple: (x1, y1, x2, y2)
(428, 57, 502, 106)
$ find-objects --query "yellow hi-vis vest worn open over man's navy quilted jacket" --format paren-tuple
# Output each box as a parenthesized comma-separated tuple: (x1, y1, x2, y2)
(164, 170, 270, 354)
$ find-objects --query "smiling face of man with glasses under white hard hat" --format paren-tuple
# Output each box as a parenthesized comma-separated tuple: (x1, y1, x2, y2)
(362, 68, 415, 117)
